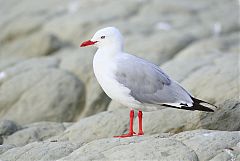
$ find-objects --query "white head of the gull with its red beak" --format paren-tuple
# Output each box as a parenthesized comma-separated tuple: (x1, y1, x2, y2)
(80, 27, 123, 50)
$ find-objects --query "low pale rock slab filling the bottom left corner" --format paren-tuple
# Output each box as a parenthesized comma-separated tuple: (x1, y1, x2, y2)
(0, 141, 79, 161)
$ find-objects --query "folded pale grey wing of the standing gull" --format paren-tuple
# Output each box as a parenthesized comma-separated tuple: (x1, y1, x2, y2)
(116, 56, 191, 104)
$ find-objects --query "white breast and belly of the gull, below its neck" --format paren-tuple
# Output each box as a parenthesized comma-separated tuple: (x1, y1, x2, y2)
(93, 52, 139, 108)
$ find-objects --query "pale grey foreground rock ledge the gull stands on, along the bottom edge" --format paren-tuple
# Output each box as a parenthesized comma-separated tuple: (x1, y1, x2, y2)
(0, 129, 236, 161)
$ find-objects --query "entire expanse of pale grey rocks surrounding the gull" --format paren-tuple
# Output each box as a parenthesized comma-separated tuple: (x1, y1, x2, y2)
(0, 0, 240, 161)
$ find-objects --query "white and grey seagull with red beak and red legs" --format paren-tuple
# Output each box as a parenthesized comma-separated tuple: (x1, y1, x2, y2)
(80, 27, 216, 138)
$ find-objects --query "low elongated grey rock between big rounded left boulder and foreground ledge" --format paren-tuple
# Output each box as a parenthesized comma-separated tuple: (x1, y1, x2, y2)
(4, 122, 71, 146)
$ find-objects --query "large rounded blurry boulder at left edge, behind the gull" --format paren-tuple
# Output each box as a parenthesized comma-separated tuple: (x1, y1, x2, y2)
(0, 58, 85, 124)
